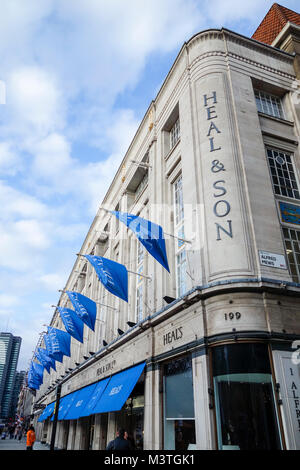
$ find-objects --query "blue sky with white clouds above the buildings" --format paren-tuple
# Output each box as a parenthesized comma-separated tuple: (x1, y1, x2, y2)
(0, 0, 299, 370)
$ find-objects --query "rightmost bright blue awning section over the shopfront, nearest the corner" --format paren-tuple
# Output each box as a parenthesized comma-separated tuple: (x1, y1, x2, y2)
(90, 362, 146, 414)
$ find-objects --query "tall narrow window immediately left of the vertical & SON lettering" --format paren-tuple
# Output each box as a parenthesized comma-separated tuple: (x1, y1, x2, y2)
(173, 176, 186, 297)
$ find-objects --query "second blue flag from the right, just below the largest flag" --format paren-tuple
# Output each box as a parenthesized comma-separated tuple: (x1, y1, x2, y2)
(85, 255, 128, 302)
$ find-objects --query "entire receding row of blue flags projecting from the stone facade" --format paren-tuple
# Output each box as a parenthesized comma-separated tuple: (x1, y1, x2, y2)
(28, 211, 170, 389)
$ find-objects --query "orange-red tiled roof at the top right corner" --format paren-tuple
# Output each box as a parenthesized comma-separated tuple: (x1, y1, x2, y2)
(252, 3, 300, 45)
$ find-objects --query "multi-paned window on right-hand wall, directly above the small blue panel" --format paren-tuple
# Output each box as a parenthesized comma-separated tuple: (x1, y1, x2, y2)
(267, 148, 300, 199)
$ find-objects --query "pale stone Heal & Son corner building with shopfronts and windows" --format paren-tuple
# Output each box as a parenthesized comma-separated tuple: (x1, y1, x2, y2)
(31, 3, 300, 450)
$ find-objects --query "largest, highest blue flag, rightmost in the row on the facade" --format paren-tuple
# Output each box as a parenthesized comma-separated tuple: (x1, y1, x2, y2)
(112, 211, 170, 272)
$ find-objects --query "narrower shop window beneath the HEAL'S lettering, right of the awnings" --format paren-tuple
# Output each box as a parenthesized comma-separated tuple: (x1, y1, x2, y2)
(163, 357, 196, 450)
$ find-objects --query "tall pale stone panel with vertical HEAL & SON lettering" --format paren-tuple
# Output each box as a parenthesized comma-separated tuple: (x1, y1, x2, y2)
(196, 73, 251, 277)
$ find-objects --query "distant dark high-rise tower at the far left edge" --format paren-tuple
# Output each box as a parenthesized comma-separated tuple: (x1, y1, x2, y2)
(0, 333, 22, 421)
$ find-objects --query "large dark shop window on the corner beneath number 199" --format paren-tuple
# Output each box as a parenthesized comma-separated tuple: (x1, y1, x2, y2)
(212, 343, 281, 450)
